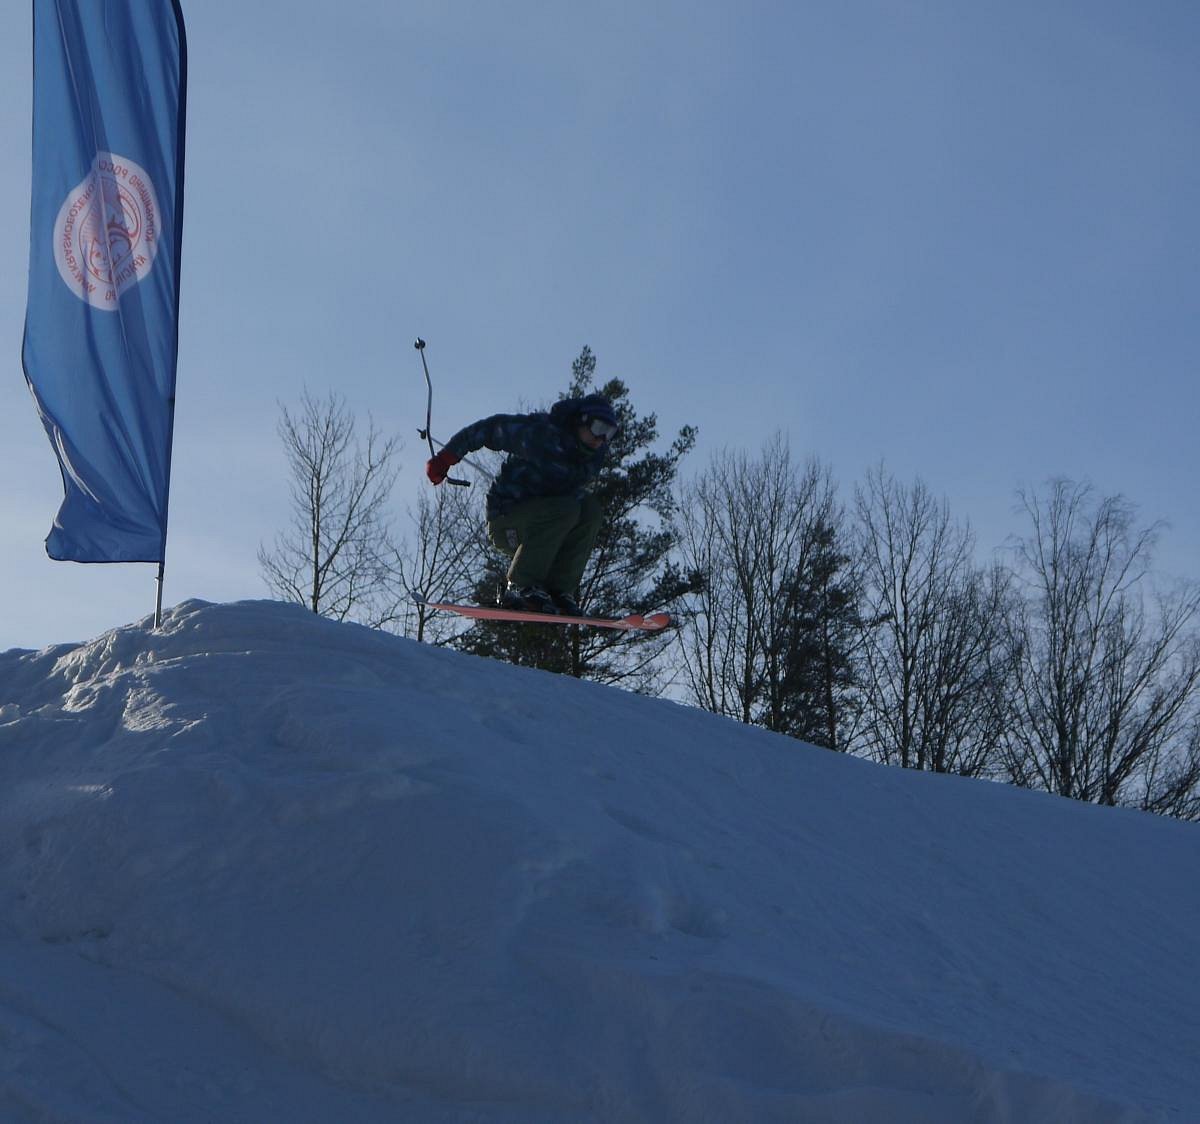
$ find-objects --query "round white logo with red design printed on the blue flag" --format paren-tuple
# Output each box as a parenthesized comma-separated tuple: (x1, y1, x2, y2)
(54, 152, 160, 312)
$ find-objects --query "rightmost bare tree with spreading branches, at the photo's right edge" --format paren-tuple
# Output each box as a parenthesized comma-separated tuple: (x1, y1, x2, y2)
(1007, 480, 1200, 810)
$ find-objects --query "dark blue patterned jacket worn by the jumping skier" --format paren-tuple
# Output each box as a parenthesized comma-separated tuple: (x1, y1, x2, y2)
(445, 398, 608, 519)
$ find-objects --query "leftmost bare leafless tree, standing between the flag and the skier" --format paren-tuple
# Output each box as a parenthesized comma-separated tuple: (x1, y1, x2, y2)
(258, 390, 397, 625)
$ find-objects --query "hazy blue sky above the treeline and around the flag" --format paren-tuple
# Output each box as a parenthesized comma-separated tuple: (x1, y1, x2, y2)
(0, 0, 1200, 649)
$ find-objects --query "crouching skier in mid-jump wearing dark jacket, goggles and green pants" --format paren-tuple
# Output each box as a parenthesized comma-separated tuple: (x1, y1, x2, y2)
(425, 395, 620, 617)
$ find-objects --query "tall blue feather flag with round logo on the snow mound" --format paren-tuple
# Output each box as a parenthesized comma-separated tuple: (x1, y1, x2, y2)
(22, 0, 187, 563)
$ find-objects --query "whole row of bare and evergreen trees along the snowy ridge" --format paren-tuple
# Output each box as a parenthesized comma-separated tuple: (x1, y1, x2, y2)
(259, 348, 1200, 819)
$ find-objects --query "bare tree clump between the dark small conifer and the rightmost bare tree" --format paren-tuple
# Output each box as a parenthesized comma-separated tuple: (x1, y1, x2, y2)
(856, 465, 1006, 775)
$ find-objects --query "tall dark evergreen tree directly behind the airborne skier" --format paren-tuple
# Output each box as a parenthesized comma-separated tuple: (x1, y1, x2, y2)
(455, 347, 696, 691)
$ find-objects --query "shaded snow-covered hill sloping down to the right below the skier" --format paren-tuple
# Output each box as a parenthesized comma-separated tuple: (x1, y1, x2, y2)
(0, 601, 1200, 1124)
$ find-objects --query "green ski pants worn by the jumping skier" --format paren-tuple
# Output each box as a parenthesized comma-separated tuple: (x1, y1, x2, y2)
(487, 495, 604, 597)
